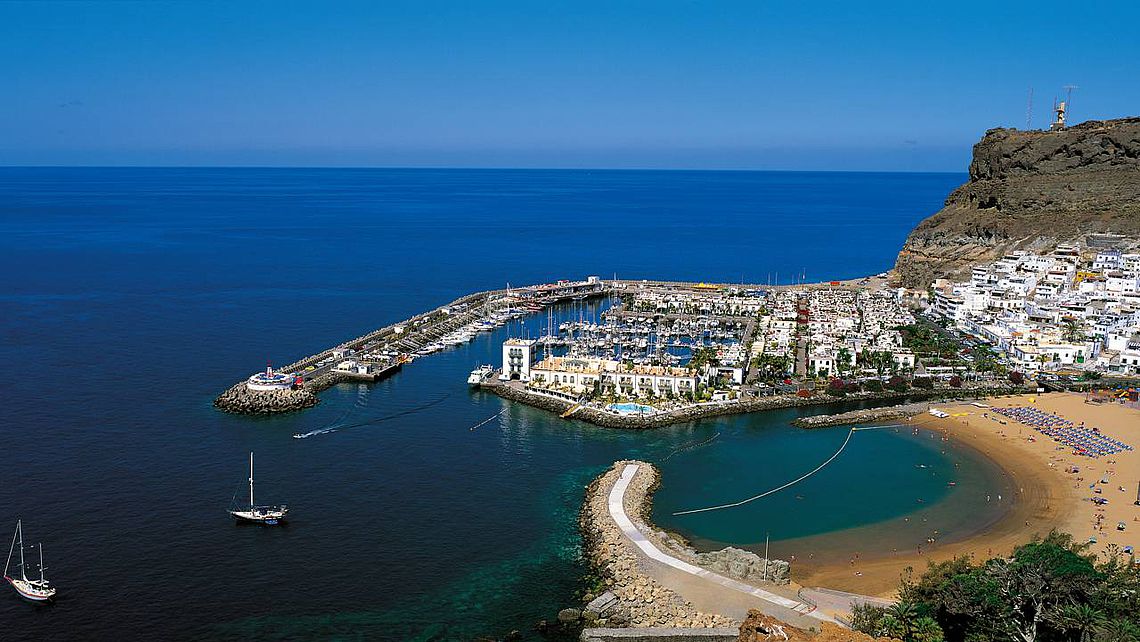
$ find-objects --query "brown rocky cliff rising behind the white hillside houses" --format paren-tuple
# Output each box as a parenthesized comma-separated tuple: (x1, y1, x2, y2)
(895, 117, 1140, 289)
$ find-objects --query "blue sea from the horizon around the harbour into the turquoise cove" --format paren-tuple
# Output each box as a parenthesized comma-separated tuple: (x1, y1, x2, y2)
(0, 168, 988, 640)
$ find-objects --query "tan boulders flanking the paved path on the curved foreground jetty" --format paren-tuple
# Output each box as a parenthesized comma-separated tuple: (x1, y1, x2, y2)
(574, 461, 789, 628)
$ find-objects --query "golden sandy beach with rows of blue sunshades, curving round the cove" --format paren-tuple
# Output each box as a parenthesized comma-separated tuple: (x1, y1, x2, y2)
(792, 393, 1140, 596)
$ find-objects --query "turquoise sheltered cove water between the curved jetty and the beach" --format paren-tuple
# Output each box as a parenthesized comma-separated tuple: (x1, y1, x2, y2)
(653, 412, 1012, 561)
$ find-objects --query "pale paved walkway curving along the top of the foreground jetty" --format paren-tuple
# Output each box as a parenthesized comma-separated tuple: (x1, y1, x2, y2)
(606, 464, 836, 627)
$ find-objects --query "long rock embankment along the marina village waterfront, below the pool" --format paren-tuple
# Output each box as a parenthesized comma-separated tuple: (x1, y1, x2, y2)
(480, 382, 1028, 430)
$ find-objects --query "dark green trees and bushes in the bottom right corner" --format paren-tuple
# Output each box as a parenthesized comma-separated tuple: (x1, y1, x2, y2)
(852, 531, 1140, 642)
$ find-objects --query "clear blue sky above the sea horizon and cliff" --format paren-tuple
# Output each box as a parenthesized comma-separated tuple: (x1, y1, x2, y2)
(0, 0, 1140, 171)
